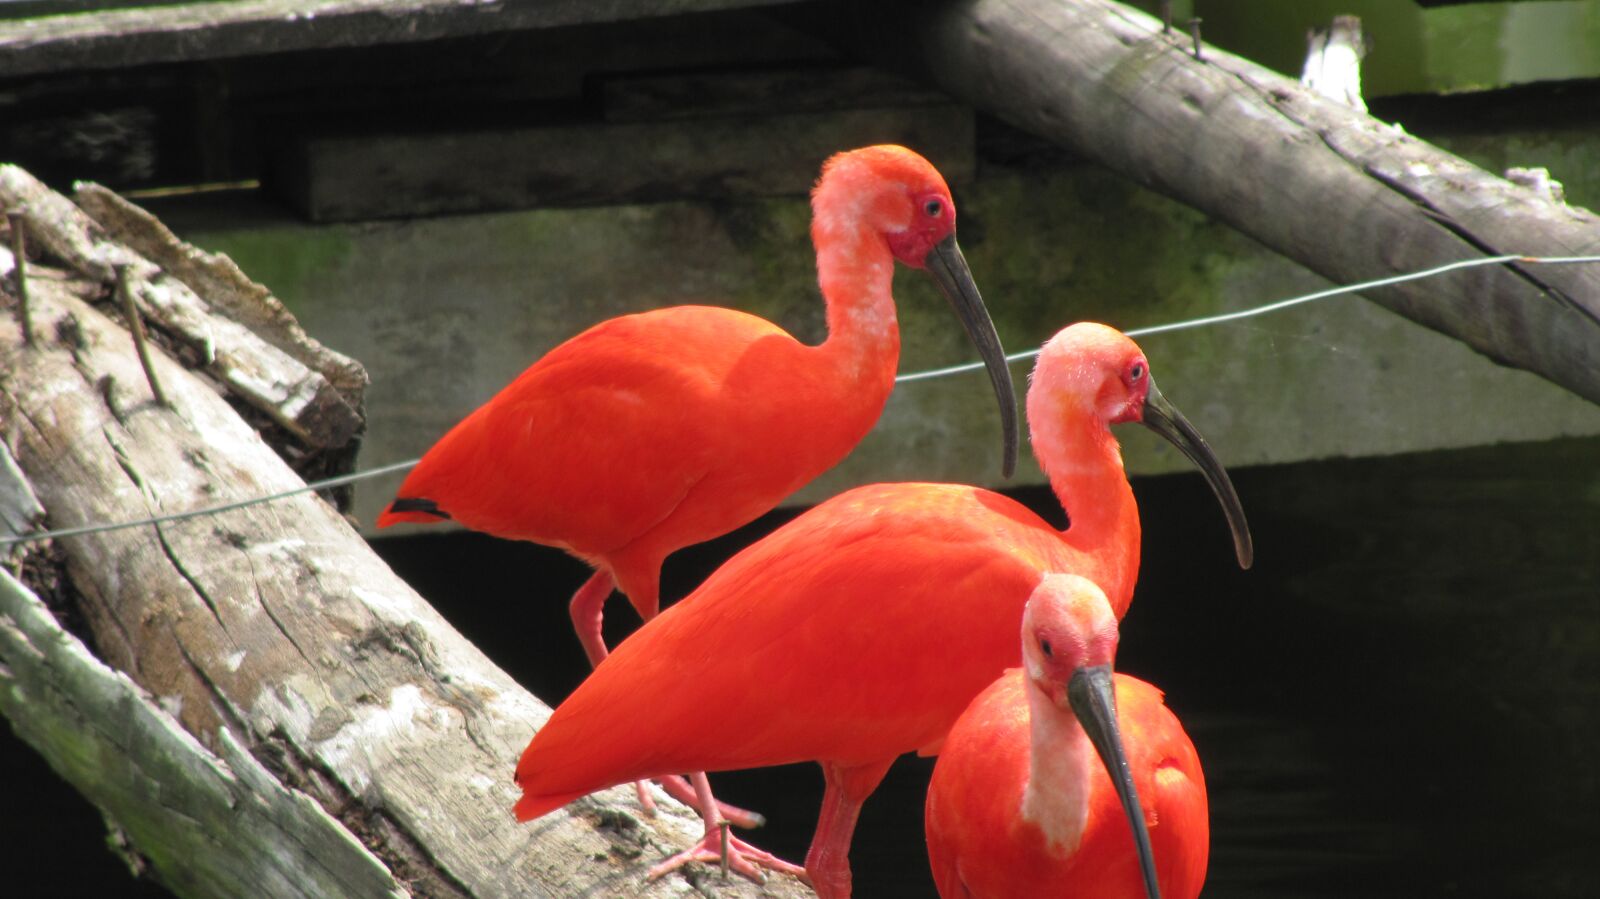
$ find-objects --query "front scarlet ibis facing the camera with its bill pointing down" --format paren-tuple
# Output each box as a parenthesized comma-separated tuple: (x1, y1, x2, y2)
(923, 574, 1211, 899)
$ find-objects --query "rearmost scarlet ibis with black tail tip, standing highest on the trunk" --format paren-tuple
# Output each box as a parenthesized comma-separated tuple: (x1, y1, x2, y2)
(378, 146, 1018, 664)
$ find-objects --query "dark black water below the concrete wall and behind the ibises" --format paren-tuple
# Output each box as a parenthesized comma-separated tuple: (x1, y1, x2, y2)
(0, 440, 1600, 897)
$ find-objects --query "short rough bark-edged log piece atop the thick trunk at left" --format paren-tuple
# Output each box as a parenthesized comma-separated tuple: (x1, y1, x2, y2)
(0, 165, 362, 448)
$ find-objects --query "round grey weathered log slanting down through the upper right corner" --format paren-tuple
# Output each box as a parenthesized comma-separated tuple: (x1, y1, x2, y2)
(803, 0, 1600, 402)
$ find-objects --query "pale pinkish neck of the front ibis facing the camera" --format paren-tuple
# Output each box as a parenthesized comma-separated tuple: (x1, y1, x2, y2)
(1021, 678, 1099, 857)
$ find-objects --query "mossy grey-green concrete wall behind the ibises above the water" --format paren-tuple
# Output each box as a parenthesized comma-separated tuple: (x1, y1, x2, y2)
(160, 134, 1600, 521)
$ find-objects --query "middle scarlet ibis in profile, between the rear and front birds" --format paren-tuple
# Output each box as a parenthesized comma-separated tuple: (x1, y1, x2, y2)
(515, 323, 1253, 899)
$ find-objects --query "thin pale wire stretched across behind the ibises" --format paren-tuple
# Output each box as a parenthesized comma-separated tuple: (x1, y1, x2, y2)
(0, 254, 1600, 547)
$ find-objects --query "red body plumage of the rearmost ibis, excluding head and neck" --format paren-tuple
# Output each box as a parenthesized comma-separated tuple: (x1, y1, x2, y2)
(378, 306, 899, 619)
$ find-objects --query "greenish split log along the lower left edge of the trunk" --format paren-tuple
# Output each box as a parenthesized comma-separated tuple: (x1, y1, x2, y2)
(0, 569, 406, 897)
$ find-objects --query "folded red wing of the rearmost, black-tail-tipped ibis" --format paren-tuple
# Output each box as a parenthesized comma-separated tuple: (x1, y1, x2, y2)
(379, 307, 782, 552)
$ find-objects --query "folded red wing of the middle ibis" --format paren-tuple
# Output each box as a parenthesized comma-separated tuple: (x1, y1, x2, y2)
(518, 485, 1038, 806)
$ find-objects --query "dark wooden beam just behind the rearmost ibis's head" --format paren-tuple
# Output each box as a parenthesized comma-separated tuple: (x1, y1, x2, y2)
(272, 104, 976, 222)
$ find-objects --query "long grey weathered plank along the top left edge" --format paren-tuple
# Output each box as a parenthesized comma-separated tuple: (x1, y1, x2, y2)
(0, 0, 789, 77)
